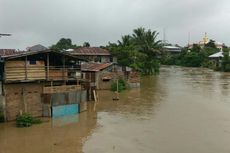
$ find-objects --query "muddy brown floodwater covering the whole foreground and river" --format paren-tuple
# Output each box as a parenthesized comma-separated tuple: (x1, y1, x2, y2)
(0, 66, 230, 153)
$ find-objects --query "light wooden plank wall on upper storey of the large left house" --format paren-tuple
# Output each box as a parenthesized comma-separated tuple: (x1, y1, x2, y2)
(5, 61, 46, 81)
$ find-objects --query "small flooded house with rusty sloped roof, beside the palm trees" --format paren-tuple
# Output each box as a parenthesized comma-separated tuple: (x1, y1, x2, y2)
(81, 63, 140, 100)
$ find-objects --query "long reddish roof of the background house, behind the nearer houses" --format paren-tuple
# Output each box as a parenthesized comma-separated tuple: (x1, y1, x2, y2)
(70, 47, 110, 56)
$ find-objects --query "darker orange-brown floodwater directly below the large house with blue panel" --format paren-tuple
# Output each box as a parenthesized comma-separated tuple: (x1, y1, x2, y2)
(0, 106, 97, 153)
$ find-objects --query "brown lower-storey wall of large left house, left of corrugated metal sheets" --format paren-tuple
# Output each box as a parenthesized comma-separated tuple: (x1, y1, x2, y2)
(4, 83, 43, 121)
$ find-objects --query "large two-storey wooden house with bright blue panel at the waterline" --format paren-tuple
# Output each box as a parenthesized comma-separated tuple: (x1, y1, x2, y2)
(0, 50, 86, 121)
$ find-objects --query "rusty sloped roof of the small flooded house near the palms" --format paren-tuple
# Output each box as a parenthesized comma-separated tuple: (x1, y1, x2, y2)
(81, 63, 113, 72)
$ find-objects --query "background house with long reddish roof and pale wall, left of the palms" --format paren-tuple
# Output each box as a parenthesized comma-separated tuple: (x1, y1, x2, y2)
(68, 47, 117, 63)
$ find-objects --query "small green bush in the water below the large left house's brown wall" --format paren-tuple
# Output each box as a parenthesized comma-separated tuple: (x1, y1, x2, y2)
(16, 113, 41, 127)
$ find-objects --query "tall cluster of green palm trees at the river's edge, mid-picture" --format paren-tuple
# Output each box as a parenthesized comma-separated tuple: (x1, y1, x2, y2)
(107, 27, 162, 75)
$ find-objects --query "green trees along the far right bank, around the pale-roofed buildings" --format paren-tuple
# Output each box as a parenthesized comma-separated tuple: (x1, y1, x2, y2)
(161, 40, 230, 71)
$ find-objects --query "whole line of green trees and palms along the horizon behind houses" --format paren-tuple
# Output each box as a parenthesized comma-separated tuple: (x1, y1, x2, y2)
(50, 27, 230, 75)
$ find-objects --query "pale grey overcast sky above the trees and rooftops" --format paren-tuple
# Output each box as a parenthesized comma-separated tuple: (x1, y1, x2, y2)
(0, 0, 230, 49)
